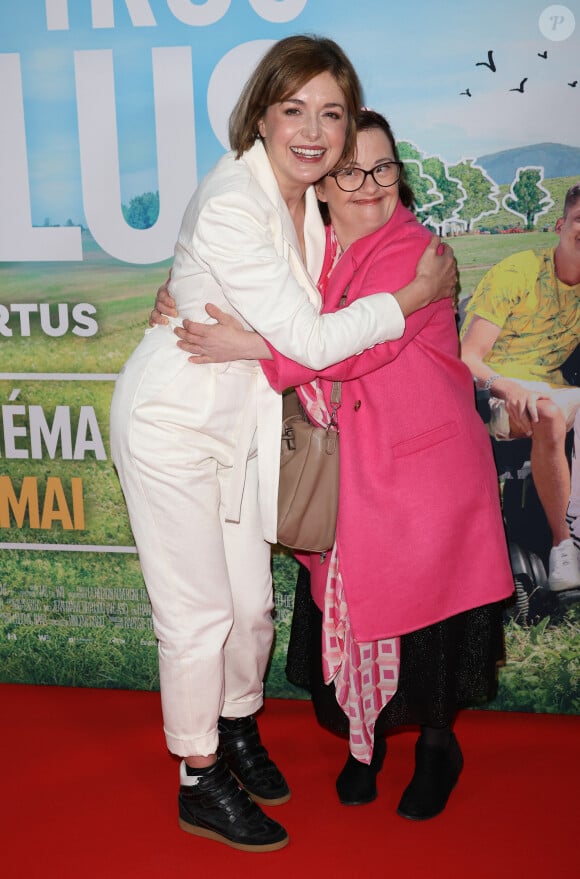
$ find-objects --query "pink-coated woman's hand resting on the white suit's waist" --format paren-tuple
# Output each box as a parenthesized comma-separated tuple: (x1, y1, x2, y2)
(173, 303, 272, 364)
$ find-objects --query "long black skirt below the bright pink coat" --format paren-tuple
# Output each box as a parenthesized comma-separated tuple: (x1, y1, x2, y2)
(286, 565, 504, 736)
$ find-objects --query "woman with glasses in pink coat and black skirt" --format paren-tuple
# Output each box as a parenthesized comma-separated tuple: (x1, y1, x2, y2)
(157, 110, 513, 820)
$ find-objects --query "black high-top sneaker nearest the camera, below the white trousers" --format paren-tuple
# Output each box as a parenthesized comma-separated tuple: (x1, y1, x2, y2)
(179, 757, 288, 852)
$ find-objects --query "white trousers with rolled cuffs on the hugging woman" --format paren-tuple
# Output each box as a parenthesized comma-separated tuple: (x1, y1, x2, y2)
(111, 335, 274, 756)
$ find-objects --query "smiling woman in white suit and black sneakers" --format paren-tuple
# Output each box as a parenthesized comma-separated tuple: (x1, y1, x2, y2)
(111, 36, 454, 851)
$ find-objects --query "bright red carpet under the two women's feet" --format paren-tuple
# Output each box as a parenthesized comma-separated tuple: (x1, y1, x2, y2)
(0, 684, 580, 879)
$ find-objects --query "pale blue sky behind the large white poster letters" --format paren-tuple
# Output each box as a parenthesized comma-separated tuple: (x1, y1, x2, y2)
(0, 0, 580, 224)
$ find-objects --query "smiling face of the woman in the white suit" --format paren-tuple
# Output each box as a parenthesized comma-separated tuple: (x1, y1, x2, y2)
(258, 73, 347, 202)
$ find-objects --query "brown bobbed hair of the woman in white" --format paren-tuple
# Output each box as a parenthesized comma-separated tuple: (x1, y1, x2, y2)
(229, 34, 362, 162)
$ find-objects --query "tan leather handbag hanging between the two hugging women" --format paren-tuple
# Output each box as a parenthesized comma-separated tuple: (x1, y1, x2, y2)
(278, 382, 341, 552)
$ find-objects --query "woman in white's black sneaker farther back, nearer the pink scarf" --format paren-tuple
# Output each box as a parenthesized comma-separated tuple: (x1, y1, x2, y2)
(218, 717, 290, 806)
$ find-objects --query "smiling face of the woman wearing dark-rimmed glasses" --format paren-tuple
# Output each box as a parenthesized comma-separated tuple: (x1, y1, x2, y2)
(316, 128, 399, 250)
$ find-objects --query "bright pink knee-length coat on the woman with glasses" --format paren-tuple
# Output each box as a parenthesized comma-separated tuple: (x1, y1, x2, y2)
(263, 203, 513, 641)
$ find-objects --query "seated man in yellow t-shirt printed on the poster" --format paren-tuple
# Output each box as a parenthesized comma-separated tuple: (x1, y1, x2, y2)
(461, 183, 580, 590)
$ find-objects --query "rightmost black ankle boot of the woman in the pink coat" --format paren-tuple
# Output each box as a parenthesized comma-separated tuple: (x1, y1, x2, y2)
(397, 733, 463, 821)
